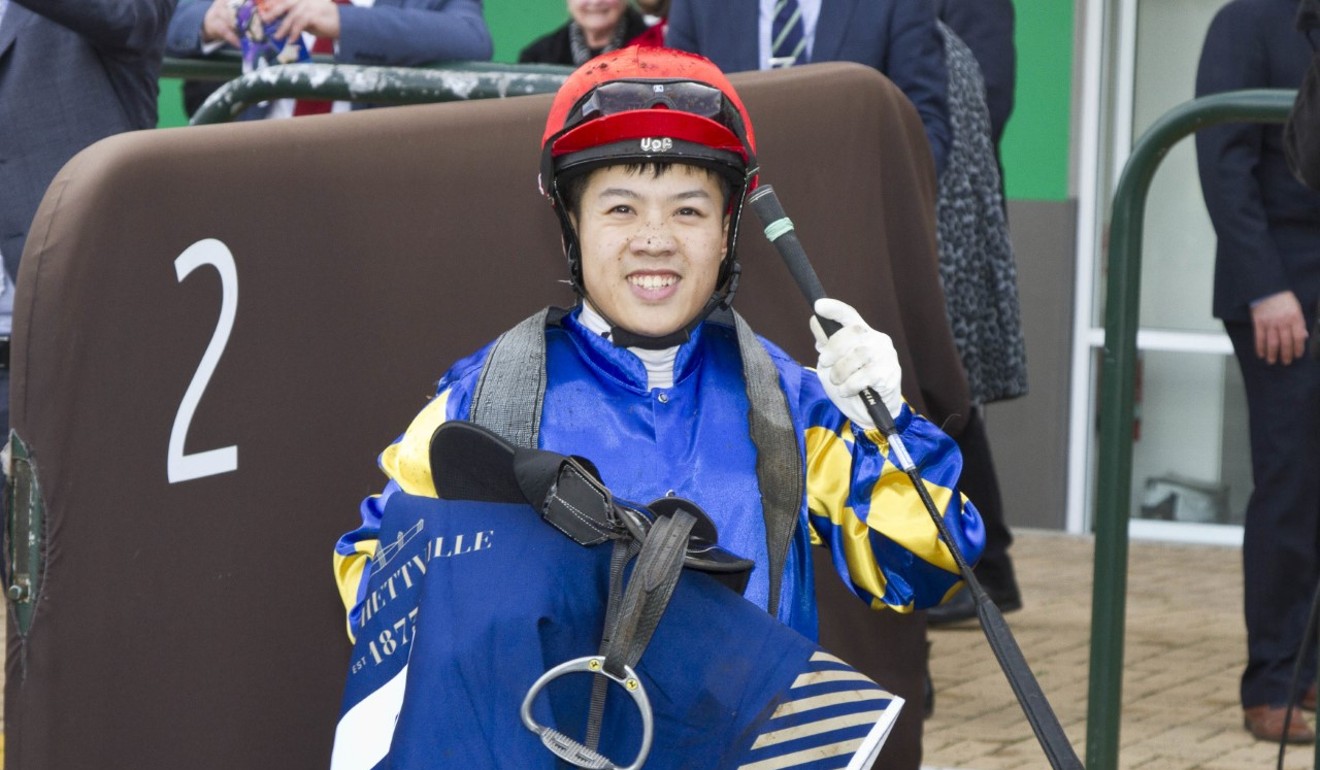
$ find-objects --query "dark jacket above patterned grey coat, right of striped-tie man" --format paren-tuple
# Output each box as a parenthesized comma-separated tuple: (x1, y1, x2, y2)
(935, 0, 1018, 147)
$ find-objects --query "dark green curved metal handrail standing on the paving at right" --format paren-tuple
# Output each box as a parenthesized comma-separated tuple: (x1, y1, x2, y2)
(1086, 90, 1293, 770)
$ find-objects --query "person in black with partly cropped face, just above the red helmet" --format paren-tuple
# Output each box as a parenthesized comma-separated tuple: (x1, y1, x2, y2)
(517, 0, 647, 66)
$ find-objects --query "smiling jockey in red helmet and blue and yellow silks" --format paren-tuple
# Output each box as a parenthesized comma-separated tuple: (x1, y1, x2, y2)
(334, 48, 983, 639)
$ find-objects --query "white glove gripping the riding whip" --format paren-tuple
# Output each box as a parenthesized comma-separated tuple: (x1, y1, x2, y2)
(810, 298, 903, 431)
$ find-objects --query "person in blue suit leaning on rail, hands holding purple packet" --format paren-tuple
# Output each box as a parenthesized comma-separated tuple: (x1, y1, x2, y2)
(166, 0, 494, 119)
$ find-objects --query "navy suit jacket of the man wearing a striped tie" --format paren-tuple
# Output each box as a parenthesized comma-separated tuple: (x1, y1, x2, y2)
(665, 0, 949, 172)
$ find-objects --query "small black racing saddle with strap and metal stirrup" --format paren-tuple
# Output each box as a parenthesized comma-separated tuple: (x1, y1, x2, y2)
(430, 421, 754, 770)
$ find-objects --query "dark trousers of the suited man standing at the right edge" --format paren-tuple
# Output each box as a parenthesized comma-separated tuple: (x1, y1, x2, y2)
(1224, 318, 1320, 707)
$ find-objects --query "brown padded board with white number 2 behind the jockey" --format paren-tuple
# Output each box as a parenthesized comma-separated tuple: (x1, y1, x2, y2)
(4, 65, 968, 769)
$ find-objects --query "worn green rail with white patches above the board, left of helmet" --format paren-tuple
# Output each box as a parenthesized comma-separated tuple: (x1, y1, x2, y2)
(161, 52, 573, 125)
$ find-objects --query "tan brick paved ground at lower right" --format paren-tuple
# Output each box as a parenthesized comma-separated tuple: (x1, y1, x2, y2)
(924, 530, 1315, 770)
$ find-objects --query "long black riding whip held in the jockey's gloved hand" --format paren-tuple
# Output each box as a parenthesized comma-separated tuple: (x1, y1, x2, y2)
(747, 185, 1084, 770)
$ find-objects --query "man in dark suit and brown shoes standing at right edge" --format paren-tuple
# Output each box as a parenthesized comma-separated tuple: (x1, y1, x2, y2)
(1196, 0, 1320, 742)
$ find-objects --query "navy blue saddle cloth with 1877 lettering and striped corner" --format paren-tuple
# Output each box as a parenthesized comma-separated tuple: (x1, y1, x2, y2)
(331, 494, 902, 770)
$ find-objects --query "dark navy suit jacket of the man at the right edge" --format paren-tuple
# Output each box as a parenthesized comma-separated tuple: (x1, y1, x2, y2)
(1196, 0, 1320, 321)
